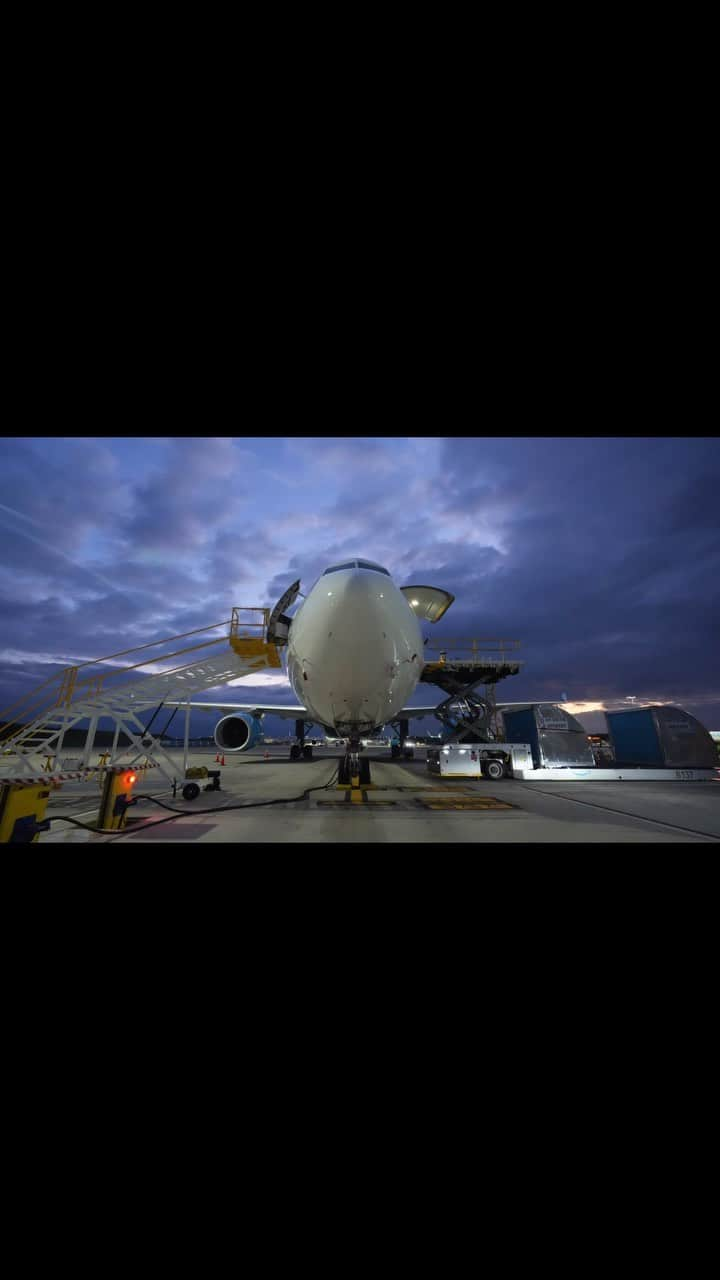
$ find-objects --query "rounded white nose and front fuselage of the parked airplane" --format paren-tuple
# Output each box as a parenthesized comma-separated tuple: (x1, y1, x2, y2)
(287, 568, 424, 735)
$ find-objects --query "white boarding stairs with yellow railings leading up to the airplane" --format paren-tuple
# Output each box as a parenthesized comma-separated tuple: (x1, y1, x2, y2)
(0, 605, 282, 783)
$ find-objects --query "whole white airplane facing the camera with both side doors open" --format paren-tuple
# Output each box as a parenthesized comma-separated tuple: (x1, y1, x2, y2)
(167, 558, 455, 785)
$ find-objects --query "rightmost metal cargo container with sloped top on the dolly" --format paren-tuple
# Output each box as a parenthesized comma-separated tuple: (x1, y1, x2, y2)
(605, 707, 717, 769)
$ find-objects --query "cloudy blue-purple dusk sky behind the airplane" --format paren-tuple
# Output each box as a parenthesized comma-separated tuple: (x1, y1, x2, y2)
(0, 436, 720, 732)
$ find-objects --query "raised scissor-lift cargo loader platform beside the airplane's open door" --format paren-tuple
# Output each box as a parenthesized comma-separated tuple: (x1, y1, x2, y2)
(420, 639, 524, 742)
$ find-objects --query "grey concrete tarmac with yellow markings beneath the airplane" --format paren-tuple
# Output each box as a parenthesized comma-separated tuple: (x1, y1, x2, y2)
(36, 746, 720, 847)
